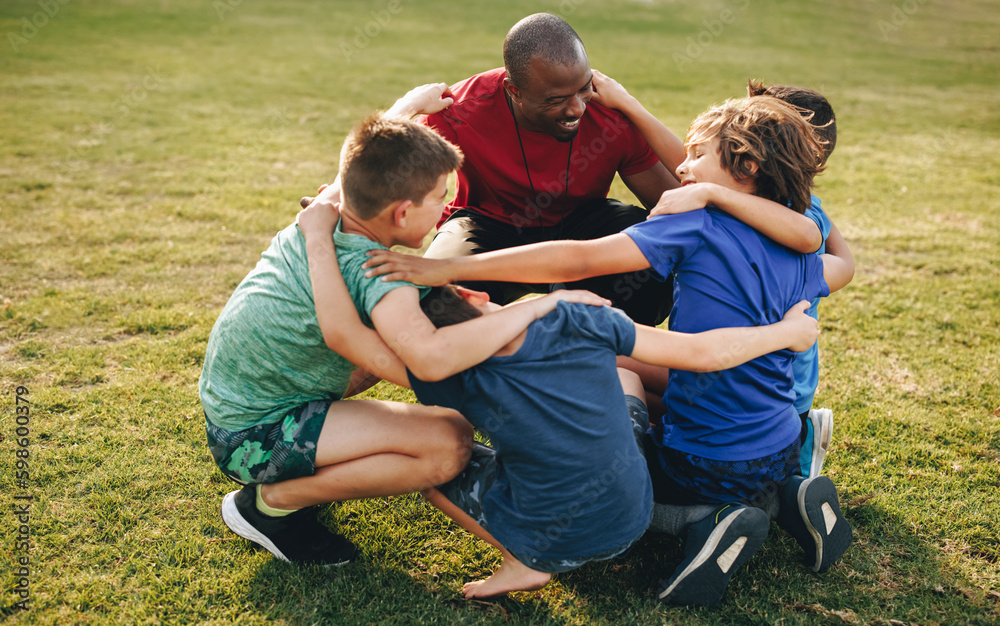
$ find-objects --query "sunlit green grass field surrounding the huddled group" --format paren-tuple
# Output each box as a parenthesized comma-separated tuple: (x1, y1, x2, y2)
(0, 0, 1000, 624)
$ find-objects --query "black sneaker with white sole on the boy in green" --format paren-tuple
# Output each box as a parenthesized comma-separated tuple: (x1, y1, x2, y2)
(222, 485, 357, 566)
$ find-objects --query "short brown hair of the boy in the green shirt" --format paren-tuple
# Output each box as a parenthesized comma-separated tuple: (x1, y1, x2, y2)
(340, 113, 462, 220)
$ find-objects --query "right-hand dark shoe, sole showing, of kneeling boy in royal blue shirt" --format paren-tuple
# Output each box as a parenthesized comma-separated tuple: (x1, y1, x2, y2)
(777, 476, 854, 572)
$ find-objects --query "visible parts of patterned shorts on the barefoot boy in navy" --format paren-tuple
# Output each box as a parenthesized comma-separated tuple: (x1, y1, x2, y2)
(437, 442, 634, 574)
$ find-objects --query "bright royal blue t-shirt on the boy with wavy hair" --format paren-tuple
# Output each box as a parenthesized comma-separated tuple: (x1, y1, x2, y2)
(623, 208, 829, 461)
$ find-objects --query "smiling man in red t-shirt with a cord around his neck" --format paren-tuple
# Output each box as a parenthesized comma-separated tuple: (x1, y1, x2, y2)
(421, 13, 684, 325)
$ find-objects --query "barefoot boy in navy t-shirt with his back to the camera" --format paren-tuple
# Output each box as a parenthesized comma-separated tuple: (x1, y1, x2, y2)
(410, 285, 817, 597)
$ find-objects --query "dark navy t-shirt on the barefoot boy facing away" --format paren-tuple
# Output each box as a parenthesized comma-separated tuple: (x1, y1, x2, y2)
(410, 302, 653, 560)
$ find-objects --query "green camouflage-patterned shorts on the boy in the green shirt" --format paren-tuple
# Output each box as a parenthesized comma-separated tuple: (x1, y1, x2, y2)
(205, 400, 333, 485)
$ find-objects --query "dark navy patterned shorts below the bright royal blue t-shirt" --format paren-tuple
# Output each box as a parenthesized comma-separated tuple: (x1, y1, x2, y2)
(645, 427, 800, 507)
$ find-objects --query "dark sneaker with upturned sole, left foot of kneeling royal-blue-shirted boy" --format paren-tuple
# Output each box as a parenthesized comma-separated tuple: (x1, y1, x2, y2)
(656, 504, 771, 606)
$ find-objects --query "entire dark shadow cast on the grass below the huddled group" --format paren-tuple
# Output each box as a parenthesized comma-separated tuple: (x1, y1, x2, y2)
(236, 498, 1000, 624)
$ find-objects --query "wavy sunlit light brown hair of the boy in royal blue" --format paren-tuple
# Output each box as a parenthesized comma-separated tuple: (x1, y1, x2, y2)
(684, 96, 823, 213)
